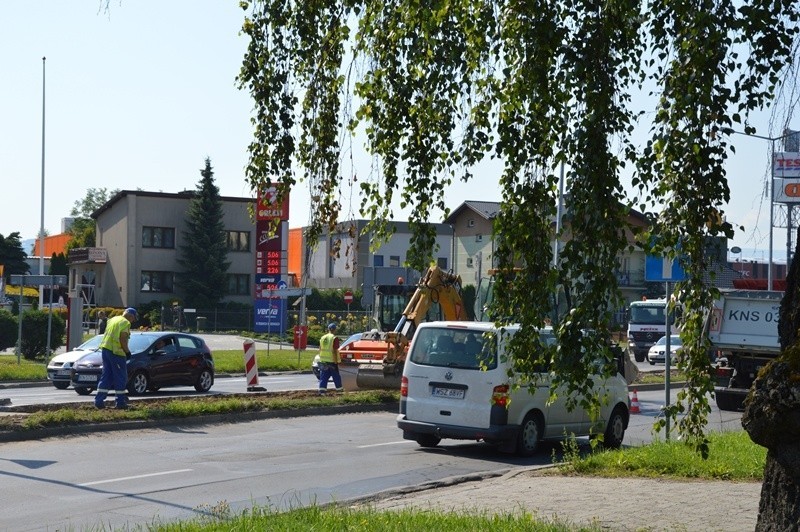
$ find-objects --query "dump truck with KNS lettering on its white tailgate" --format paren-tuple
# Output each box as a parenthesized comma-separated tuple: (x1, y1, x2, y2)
(708, 290, 783, 411)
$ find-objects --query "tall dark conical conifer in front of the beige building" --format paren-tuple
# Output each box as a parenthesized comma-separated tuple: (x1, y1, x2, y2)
(177, 158, 230, 309)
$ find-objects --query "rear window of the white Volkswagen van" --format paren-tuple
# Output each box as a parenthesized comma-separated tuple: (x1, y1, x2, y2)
(409, 327, 497, 370)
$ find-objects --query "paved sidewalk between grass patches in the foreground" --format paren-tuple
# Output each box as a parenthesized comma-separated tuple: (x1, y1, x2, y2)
(354, 468, 761, 532)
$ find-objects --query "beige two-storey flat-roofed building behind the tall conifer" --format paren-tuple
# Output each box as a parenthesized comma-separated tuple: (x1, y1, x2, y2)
(70, 190, 255, 307)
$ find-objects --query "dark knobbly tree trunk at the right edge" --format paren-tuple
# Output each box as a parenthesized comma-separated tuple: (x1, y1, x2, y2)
(742, 228, 800, 531)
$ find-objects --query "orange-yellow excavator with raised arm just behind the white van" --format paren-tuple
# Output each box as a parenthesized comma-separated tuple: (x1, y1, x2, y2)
(339, 266, 468, 389)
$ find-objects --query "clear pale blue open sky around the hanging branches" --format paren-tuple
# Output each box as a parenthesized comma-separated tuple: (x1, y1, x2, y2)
(0, 0, 800, 260)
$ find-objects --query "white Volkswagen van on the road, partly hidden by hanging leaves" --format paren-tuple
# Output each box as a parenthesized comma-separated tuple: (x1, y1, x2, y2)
(397, 321, 630, 456)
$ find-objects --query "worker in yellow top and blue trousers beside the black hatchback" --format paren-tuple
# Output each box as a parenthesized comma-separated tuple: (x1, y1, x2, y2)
(94, 308, 136, 409)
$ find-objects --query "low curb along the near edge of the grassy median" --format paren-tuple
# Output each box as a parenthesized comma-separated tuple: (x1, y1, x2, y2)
(0, 403, 398, 443)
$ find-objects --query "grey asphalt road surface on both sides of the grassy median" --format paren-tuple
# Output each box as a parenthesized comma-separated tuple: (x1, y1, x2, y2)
(0, 339, 752, 530)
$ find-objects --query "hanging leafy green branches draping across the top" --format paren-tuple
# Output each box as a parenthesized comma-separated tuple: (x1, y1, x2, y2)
(234, 0, 800, 526)
